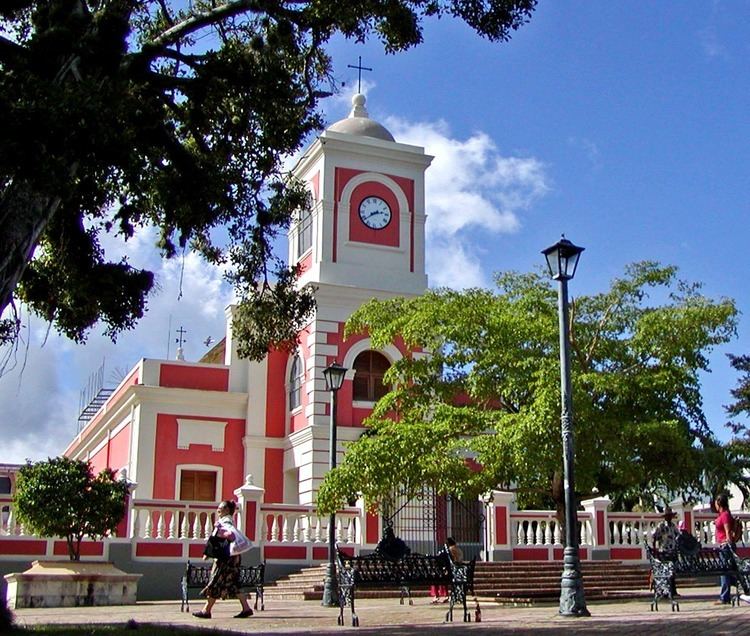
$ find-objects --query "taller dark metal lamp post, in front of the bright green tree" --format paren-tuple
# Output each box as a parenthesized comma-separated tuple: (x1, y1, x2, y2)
(542, 236, 591, 616)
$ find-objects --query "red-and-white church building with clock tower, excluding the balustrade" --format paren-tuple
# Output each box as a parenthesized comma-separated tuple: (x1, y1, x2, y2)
(65, 89, 432, 532)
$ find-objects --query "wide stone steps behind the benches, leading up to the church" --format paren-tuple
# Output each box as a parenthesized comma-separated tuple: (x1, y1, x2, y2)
(265, 561, 706, 605)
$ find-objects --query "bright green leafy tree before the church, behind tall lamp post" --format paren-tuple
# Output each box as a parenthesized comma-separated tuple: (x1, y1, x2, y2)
(319, 262, 737, 518)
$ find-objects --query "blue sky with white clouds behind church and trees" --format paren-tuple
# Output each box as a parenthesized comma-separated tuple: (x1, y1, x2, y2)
(0, 0, 750, 463)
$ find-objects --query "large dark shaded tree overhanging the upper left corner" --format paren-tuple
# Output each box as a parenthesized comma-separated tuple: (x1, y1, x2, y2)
(0, 0, 536, 357)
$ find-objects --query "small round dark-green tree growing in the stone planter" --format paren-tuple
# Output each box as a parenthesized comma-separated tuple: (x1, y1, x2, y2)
(13, 457, 128, 561)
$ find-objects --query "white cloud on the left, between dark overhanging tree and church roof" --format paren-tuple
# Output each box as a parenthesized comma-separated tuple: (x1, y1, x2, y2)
(0, 230, 232, 463)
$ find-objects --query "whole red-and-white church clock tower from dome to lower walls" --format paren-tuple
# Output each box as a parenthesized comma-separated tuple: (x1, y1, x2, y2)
(280, 94, 432, 504)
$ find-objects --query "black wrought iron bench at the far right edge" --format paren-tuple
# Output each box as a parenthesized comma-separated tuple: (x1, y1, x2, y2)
(646, 546, 750, 612)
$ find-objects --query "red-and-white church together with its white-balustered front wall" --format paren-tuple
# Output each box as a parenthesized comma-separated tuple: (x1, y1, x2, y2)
(0, 95, 750, 598)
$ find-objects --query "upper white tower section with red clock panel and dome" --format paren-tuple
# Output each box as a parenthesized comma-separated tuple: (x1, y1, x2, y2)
(289, 94, 432, 297)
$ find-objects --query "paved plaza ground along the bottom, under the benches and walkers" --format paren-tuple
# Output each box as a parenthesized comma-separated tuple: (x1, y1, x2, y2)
(8, 587, 750, 636)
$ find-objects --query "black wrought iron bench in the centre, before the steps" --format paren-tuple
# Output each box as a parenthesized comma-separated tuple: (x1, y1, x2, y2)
(336, 546, 479, 627)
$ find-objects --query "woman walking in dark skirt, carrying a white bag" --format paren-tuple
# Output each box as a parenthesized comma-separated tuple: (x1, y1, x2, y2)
(193, 500, 253, 618)
